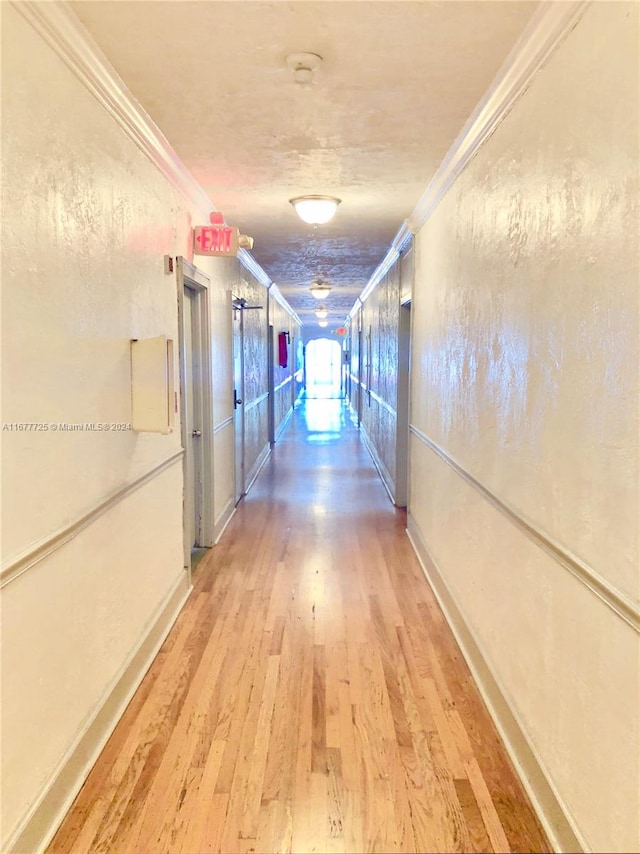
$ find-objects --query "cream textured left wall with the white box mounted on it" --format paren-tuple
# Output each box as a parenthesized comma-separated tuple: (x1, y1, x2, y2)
(1, 4, 266, 850)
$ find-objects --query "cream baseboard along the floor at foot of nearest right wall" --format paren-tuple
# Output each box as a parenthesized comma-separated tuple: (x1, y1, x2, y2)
(407, 514, 589, 854)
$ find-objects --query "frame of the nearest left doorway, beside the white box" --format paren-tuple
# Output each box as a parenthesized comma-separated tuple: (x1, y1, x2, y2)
(176, 255, 214, 571)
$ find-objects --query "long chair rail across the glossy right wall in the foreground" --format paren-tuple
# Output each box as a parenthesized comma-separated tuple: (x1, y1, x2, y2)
(409, 424, 640, 632)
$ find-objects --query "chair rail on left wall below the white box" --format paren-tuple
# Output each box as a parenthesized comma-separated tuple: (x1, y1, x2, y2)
(0, 448, 184, 588)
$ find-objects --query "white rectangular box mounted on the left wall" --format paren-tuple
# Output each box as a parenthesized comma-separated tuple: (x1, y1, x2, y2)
(131, 335, 175, 434)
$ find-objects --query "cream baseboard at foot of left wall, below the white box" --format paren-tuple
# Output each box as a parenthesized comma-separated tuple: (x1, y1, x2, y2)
(3, 572, 191, 854)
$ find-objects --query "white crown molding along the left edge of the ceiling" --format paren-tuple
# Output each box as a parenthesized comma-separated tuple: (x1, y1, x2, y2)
(11, 0, 288, 314)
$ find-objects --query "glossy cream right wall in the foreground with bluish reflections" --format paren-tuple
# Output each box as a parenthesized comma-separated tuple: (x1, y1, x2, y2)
(410, 3, 640, 852)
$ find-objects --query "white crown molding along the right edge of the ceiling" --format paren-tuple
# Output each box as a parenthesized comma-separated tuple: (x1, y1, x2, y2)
(347, 0, 591, 321)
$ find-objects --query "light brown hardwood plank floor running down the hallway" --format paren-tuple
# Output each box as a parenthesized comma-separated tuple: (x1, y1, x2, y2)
(48, 400, 550, 854)
